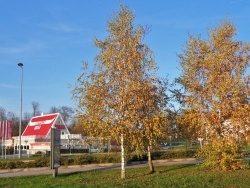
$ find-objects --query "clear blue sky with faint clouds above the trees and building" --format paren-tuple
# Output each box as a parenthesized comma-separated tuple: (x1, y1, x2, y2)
(0, 0, 250, 115)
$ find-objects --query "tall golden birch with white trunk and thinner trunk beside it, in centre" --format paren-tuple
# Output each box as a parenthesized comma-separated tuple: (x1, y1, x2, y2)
(73, 6, 167, 179)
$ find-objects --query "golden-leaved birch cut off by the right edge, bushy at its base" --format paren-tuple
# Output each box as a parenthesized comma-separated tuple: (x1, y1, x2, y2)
(179, 20, 250, 169)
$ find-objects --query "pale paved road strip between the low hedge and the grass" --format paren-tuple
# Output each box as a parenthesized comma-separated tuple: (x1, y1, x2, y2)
(0, 158, 200, 178)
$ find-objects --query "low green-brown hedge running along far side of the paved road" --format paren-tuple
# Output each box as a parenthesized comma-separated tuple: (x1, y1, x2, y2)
(0, 150, 196, 169)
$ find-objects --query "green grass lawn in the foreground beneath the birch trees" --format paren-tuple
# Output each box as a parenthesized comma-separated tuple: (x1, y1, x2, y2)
(0, 165, 250, 188)
